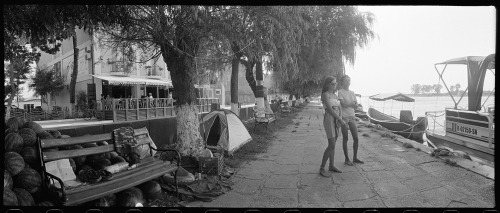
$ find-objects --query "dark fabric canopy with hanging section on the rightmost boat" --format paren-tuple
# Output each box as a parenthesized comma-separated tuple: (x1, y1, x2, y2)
(436, 54, 495, 111)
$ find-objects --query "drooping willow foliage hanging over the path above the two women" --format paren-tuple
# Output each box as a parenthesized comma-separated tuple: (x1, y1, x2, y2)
(273, 6, 375, 95)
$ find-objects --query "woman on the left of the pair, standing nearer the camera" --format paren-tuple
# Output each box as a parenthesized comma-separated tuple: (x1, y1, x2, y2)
(319, 76, 346, 177)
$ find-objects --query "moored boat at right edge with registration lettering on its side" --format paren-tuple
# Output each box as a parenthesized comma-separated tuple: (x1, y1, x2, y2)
(426, 54, 495, 164)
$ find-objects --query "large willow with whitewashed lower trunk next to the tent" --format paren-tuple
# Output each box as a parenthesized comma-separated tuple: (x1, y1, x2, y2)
(94, 5, 232, 156)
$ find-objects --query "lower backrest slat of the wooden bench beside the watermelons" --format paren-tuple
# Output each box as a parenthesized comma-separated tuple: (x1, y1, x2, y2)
(42, 144, 115, 162)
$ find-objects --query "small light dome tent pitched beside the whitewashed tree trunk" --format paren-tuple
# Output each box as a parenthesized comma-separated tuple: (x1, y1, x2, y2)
(200, 109, 252, 154)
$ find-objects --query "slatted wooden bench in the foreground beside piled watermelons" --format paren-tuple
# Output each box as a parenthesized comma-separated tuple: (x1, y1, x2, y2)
(39, 127, 181, 206)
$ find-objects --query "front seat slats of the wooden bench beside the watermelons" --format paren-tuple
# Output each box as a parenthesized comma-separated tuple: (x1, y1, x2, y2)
(65, 162, 177, 206)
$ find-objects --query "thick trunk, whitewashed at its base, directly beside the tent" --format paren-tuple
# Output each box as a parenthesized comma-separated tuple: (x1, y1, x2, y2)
(161, 32, 205, 157)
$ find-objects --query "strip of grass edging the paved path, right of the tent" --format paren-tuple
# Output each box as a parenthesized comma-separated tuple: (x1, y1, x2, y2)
(224, 106, 304, 168)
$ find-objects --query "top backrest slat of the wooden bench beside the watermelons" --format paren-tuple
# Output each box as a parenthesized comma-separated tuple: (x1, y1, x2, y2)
(40, 133, 113, 149)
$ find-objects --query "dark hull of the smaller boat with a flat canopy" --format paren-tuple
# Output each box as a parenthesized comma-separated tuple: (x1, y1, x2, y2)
(366, 108, 425, 143)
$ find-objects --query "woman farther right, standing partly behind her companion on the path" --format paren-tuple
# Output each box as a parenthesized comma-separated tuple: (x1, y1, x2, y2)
(339, 75, 364, 166)
